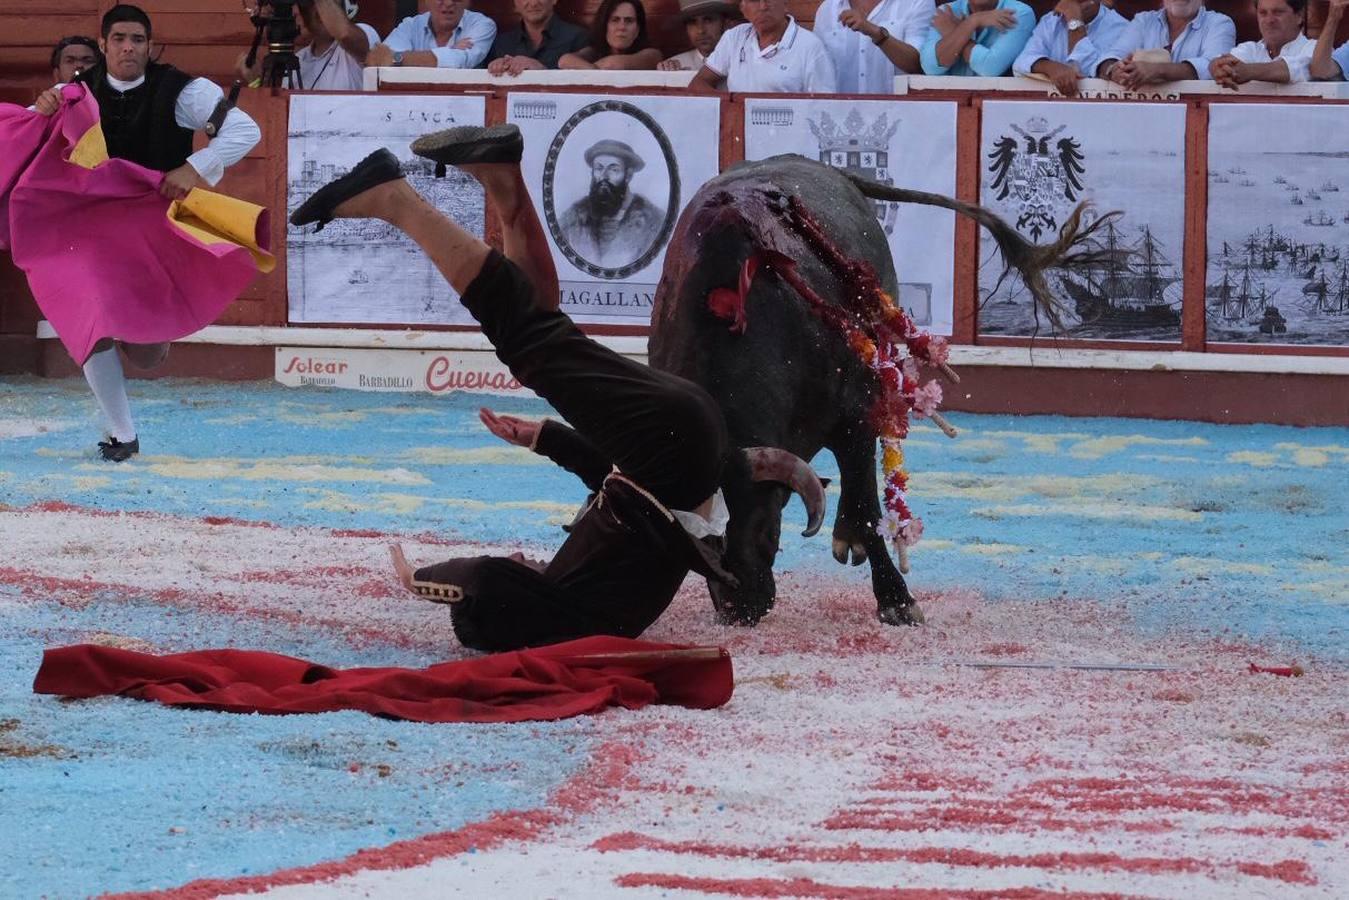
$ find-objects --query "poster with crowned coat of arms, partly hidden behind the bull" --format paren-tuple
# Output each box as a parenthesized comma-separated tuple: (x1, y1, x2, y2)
(745, 97, 955, 335)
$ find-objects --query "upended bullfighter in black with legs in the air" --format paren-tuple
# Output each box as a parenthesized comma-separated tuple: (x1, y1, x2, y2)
(290, 125, 824, 650)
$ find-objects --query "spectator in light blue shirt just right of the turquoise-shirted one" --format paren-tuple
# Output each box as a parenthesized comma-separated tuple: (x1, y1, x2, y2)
(1012, 0, 1129, 97)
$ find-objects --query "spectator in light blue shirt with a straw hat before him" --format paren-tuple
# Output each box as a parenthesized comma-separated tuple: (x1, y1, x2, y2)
(1097, 0, 1237, 90)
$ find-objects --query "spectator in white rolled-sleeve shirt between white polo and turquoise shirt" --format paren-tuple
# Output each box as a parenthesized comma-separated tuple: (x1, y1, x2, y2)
(815, 0, 936, 93)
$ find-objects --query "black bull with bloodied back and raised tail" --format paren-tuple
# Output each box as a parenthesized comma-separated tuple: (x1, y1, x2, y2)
(649, 157, 1106, 625)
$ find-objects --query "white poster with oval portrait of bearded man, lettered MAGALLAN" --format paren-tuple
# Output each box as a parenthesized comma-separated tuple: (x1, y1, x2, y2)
(506, 92, 720, 325)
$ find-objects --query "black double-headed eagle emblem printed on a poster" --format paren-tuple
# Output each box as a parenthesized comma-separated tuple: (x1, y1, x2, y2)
(989, 116, 1086, 242)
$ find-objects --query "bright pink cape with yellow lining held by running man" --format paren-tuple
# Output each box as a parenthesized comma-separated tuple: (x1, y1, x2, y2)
(0, 85, 270, 363)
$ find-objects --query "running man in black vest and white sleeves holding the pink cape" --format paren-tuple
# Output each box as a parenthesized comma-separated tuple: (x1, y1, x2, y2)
(34, 4, 262, 463)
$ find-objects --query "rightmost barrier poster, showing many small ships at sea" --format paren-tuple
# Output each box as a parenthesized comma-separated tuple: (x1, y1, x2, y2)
(1205, 104, 1349, 347)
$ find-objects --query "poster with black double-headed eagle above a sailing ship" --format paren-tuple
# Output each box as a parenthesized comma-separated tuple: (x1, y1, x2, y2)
(979, 101, 1186, 341)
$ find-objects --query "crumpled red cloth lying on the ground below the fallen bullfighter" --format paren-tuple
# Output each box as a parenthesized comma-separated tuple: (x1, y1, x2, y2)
(32, 637, 735, 722)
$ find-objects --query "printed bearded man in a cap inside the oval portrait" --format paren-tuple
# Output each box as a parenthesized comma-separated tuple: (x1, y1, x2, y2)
(557, 138, 665, 269)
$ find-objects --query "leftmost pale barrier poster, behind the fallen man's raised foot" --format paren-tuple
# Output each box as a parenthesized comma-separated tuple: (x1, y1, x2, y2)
(286, 93, 487, 325)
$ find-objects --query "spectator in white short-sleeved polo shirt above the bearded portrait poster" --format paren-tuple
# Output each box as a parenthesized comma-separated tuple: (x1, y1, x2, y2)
(689, 0, 838, 93)
